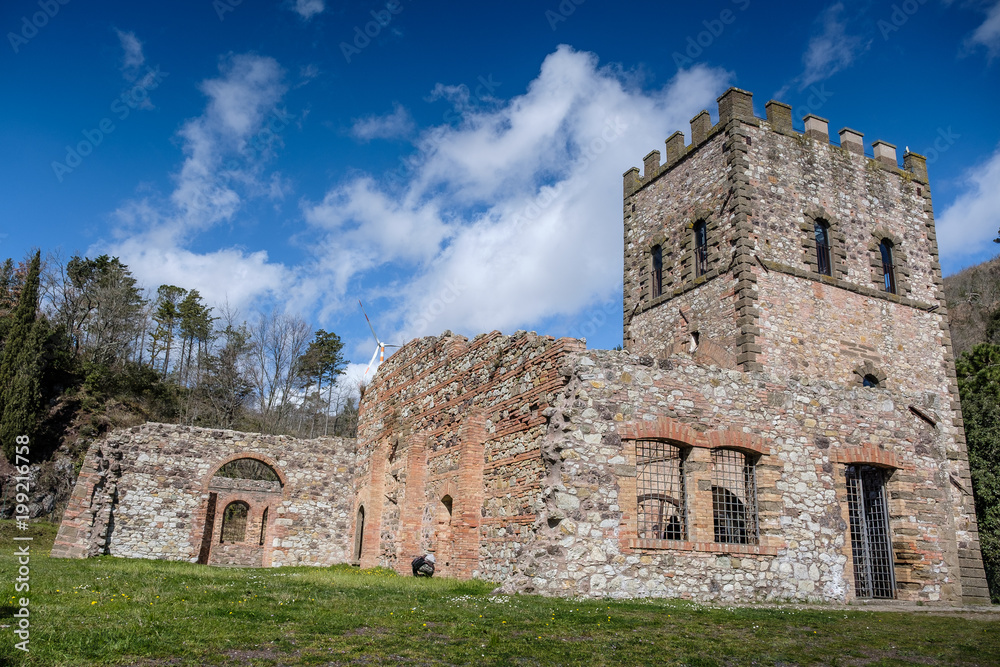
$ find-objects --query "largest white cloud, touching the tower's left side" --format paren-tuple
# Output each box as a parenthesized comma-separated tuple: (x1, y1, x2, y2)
(304, 46, 728, 341)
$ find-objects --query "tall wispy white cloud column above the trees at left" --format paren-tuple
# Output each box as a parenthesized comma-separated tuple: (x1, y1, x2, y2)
(103, 54, 299, 314)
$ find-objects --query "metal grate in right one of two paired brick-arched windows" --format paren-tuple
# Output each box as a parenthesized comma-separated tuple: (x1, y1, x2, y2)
(712, 449, 760, 544)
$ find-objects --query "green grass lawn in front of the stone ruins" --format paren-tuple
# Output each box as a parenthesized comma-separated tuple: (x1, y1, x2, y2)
(0, 522, 1000, 667)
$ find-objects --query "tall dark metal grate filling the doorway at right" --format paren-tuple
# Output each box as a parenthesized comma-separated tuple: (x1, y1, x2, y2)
(847, 466, 896, 599)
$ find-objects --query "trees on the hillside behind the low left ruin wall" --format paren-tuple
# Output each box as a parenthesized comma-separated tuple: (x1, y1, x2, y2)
(0, 252, 357, 458)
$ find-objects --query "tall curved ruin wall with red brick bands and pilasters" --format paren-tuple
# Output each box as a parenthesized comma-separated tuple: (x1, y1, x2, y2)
(353, 332, 584, 581)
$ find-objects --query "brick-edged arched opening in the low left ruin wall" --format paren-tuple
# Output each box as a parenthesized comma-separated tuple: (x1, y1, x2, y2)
(198, 456, 284, 567)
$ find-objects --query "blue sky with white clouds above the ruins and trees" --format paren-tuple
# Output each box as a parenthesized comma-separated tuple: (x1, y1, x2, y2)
(0, 0, 1000, 380)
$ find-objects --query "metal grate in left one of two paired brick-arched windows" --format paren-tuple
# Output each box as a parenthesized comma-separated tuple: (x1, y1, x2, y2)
(635, 440, 687, 540)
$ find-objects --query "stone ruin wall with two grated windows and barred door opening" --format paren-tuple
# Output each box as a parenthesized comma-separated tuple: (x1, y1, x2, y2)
(508, 351, 971, 602)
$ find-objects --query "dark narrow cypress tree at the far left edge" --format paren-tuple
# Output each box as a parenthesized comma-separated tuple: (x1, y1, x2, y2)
(0, 251, 45, 459)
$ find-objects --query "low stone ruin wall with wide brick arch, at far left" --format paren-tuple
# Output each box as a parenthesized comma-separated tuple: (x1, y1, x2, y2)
(52, 423, 355, 567)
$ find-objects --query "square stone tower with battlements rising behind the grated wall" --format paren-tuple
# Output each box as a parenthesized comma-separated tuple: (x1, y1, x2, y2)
(624, 88, 988, 601)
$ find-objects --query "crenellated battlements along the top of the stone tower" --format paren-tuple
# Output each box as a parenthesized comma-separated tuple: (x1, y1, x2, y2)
(623, 87, 927, 197)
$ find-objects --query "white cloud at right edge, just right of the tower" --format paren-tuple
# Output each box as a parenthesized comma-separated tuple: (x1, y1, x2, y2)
(937, 147, 1000, 260)
